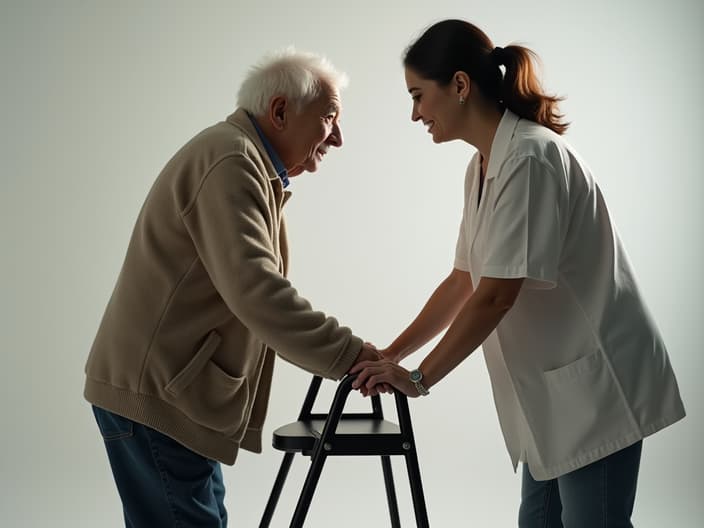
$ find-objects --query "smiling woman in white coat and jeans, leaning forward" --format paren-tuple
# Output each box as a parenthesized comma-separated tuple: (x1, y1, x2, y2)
(353, 20, 685, 528)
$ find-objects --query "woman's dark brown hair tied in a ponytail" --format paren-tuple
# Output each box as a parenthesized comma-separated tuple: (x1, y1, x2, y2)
(403, 20, 569, 134)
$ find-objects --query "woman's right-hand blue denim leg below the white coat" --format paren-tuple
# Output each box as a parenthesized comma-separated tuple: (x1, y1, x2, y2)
(557, 441, 643, 528)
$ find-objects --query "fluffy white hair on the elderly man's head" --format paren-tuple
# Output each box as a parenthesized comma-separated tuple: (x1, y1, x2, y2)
(237, 47, 348, 116)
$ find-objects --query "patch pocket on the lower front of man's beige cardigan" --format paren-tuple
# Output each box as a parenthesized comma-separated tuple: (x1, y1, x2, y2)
(165, 331, 249, 436)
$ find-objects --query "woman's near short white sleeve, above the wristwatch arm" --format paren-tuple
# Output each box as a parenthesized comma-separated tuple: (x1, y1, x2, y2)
(481, 156, 564, 289)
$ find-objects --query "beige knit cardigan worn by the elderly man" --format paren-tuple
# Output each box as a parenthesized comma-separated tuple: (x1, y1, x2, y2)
(85, 109, 362, 464)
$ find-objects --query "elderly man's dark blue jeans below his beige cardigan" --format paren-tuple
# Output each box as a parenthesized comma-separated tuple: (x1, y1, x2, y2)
(93, 406, 227, 528)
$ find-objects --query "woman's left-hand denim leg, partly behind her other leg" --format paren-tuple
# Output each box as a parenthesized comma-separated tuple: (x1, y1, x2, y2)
(518, 464, 562, 528)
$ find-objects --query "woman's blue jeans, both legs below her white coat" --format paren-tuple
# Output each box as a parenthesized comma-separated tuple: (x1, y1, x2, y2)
(518, 441, 643, 528)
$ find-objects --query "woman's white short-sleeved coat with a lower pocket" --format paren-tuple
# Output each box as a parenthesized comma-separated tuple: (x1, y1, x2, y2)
(455, 111, 685, 480)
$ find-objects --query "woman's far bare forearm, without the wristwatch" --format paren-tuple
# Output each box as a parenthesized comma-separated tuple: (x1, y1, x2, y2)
(386, 269, 472, 361)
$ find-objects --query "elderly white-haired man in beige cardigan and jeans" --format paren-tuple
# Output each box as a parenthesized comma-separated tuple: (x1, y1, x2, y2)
(85, 50, 378, 528)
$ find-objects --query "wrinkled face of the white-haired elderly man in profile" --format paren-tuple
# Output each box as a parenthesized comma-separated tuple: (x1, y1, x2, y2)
(282, 84, 342, 176)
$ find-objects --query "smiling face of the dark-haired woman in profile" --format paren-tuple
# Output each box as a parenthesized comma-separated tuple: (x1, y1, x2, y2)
(406, 68, 462, 143)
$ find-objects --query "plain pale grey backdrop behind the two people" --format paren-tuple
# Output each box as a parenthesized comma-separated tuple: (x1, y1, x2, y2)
(0, 0, 704, 528)
